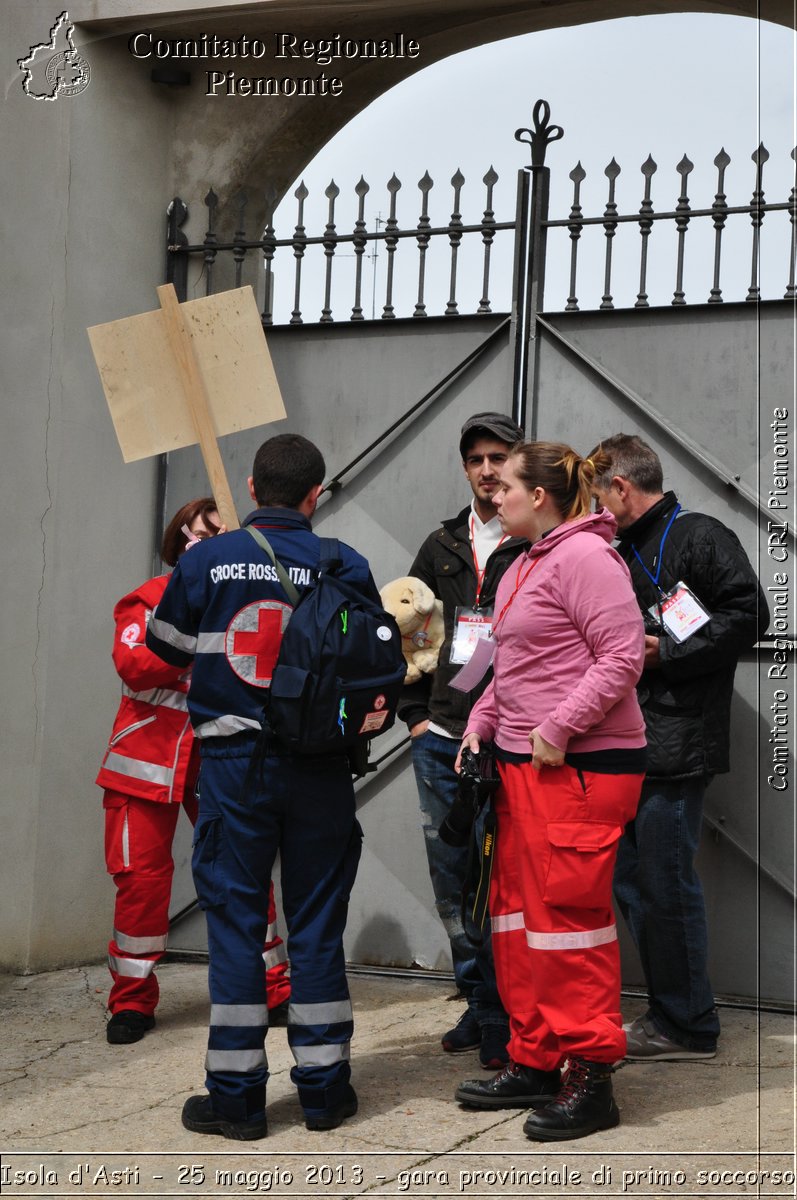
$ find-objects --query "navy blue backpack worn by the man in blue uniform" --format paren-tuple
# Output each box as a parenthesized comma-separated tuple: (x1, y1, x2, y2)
(246, 526, 407, 755)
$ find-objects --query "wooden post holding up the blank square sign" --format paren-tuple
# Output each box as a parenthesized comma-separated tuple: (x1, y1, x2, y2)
(157, 283, 240, 529)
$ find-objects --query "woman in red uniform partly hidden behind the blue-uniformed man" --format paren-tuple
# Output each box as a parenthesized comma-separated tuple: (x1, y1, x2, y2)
(96, 498, 290, 1044)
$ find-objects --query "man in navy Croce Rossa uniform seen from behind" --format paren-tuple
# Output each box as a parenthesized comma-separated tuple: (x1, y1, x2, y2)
(146, 433, 379, 1140)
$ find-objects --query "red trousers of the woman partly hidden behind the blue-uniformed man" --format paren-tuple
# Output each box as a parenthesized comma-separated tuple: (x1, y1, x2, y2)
(103, 791, 290, 1016)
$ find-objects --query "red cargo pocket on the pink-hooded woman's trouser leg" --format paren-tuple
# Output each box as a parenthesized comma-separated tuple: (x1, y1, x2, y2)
(543, 821, 623, 908)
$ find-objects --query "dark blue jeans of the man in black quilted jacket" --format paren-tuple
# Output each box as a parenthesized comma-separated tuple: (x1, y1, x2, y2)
(615, 778, 719, 1050)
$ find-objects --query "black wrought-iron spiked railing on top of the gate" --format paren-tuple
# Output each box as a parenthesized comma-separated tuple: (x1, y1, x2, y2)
(167, 101, 797, 326)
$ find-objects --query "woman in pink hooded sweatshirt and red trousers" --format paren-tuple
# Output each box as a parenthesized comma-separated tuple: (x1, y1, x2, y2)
(456, 442, 645, 1141)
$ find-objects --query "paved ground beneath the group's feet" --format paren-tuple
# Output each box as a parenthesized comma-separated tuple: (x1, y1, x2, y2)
(0, 964, 796, 1200)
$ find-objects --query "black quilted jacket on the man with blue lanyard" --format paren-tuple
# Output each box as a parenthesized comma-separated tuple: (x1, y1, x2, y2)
(617, 492, 769, 779)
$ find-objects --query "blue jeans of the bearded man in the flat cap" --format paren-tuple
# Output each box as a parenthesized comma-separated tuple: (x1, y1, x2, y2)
(412, 731, 508, 1025)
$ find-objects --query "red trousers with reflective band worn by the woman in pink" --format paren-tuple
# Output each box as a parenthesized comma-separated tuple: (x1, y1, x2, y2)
(490, 762, 643, 1070)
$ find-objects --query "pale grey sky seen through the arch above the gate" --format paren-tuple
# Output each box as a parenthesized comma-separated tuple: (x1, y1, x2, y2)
(275, 13, 797, 320)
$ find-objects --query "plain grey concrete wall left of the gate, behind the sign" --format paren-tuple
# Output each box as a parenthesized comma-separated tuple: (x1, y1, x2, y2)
(0, 2, 176, 971)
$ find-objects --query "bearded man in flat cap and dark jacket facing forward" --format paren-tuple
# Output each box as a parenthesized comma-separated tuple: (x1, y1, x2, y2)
(399, 413, 526, 1068)
